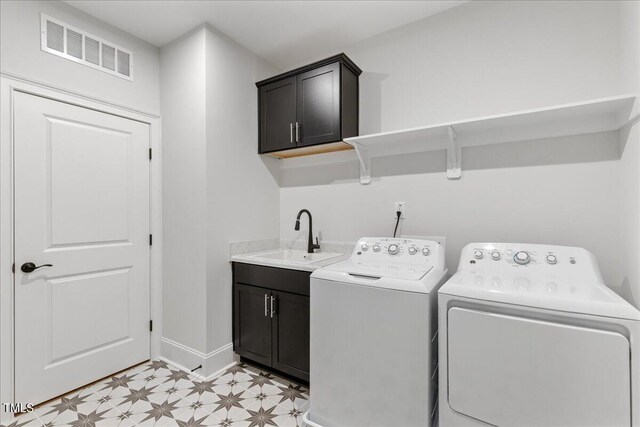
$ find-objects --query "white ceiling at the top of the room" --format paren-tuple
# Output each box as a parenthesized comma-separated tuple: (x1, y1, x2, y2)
(66, 0, 465, 68)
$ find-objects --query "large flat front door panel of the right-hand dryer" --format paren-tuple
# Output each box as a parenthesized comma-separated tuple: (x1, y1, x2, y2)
(448, 307, 631, 427)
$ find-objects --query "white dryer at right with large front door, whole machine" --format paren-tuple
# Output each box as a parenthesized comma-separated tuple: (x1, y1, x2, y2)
(438, 243, 640, 427)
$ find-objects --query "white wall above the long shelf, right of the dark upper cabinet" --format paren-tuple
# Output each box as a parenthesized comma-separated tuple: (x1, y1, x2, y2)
(345, 1, 619, 134)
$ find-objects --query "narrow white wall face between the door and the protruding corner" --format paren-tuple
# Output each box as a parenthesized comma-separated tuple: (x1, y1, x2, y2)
(160, 27, 207, 354)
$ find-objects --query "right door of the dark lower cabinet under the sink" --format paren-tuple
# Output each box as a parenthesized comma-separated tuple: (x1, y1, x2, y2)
(271, 292, 309, 381)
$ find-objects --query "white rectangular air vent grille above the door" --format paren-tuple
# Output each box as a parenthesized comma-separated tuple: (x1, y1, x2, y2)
(40, 14, 133, 80)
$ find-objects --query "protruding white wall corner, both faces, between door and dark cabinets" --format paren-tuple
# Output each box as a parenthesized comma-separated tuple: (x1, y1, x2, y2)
(161, 26, 279, 376)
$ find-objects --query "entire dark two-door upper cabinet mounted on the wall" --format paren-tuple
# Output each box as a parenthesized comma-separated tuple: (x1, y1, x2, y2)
(256, 53, 362, 158)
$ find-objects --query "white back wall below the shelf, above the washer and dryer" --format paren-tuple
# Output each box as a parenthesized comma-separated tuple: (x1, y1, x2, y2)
(280, 133, 620, 283)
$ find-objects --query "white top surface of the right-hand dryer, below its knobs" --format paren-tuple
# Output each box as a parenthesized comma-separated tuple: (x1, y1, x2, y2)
(438, 270, 640, 320)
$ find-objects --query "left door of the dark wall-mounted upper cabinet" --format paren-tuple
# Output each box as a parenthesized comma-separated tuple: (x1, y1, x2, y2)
(260, 77, 296, 153)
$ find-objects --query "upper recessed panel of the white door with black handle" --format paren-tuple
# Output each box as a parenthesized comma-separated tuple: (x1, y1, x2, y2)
(47, 118, 134, 248)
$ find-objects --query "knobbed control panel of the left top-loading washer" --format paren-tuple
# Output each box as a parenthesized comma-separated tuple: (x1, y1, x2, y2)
(351, 237, 445, 265)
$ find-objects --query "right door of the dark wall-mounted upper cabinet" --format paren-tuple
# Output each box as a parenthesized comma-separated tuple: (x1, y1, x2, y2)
(294, 63, 341, 147)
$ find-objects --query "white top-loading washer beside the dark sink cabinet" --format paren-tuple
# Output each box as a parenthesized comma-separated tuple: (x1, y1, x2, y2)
(304, 237, 447, 427)
